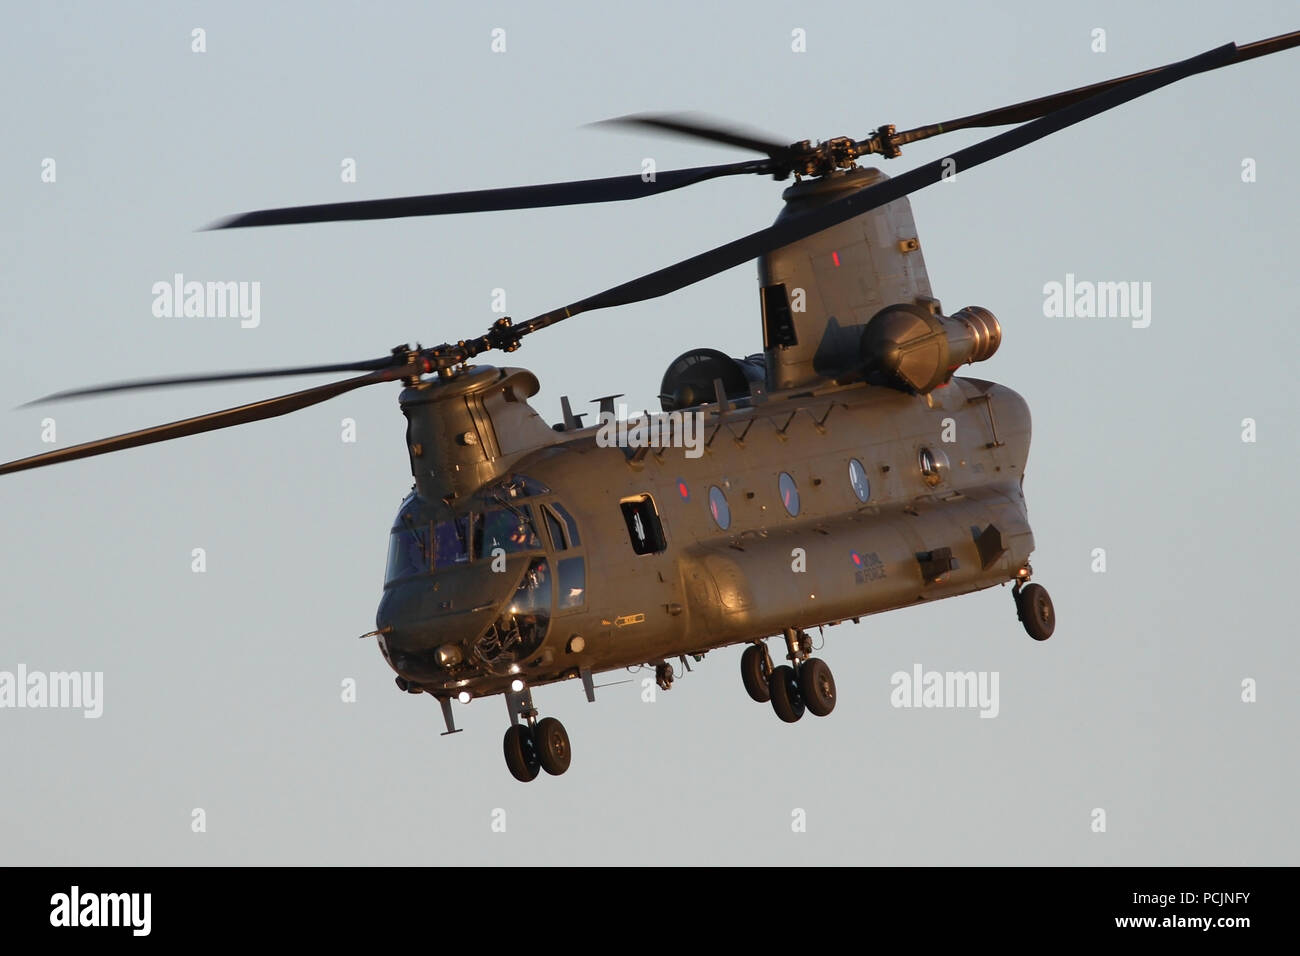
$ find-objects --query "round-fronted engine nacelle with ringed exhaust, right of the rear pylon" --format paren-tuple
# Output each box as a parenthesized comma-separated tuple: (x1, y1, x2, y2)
(861, 303, 1002, 394)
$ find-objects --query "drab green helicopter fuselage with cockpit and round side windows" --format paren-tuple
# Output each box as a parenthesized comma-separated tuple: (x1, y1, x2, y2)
(377, 369, 1034, 697)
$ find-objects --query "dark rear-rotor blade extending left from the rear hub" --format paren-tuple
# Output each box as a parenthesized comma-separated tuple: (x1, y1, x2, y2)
(204, 160, 774, 229)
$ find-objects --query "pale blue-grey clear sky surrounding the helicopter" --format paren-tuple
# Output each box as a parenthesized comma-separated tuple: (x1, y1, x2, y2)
(0, 1, 1300, 865)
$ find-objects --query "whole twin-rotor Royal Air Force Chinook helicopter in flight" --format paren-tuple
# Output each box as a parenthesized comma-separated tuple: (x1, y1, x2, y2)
(0, 33, 1300, 782)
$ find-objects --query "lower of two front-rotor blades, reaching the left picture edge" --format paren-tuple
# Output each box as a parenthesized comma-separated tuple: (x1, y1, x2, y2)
(0, 368, 395, 475)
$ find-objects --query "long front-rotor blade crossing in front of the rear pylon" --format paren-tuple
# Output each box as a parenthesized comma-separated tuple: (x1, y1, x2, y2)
(516, 43, 1238, 336)
